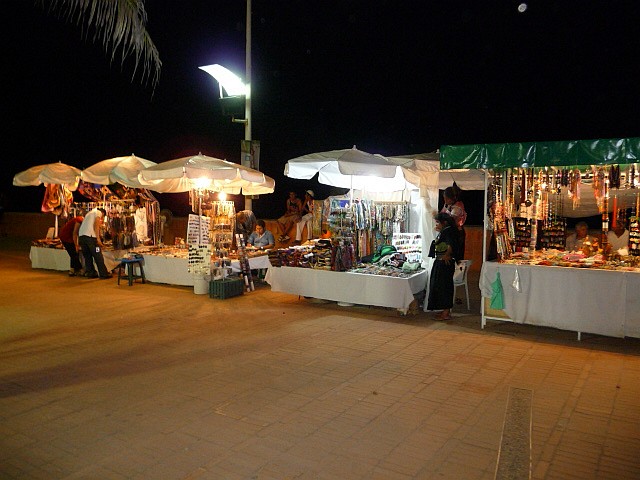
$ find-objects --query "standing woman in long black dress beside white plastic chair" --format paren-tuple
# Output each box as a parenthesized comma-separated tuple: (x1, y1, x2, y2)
(427, 213, 459, 320)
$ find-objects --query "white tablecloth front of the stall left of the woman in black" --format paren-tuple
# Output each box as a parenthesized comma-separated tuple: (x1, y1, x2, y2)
(265, 267, 427, 313)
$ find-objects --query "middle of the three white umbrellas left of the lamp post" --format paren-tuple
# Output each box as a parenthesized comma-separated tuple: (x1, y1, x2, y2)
(81, 154, 157, 188)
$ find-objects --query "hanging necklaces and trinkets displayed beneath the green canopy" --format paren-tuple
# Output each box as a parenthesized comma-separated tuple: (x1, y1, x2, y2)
(487, 165, 640, 269)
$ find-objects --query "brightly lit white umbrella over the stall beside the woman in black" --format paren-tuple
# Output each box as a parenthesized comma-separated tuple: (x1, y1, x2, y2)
(284, 146, 407, 192)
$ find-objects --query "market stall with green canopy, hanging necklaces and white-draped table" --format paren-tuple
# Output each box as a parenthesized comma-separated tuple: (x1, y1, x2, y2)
(441, 138, 640, 337)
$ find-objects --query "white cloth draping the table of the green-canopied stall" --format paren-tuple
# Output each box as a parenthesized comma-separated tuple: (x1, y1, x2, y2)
(480, 262, 640, 338)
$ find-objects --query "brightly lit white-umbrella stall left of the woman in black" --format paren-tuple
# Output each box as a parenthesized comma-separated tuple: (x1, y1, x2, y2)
(266, 147, 437, 313)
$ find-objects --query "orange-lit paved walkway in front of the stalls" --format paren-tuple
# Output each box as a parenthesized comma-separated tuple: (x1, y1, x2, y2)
(0, 238, 640, 480)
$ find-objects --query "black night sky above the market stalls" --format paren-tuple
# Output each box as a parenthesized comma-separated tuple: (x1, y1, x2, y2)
(0, 0, 640, 218)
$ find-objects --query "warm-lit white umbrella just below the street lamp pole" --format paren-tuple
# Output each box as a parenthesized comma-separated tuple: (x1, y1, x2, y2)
(138, 154, 276, 195)
